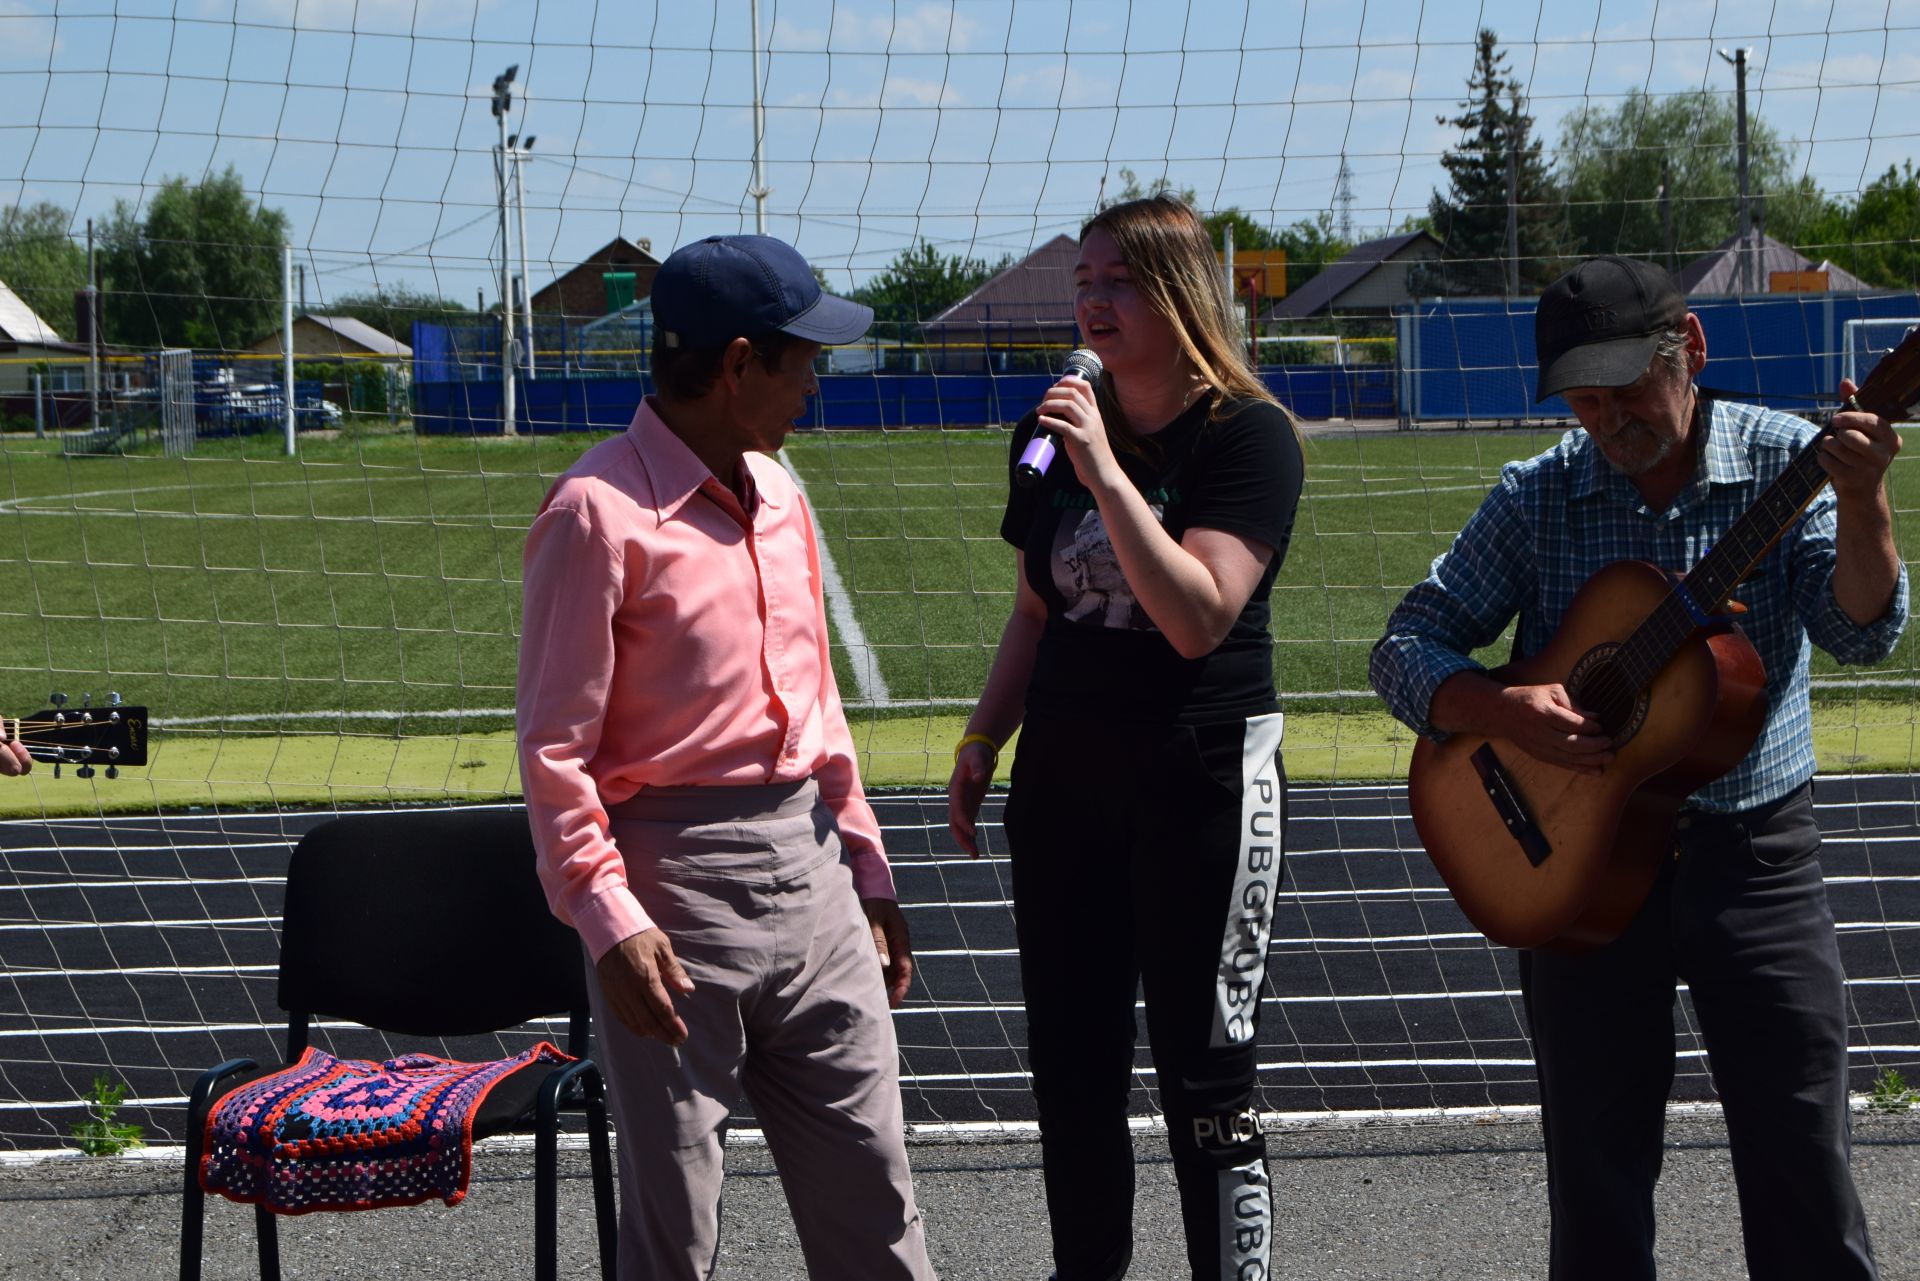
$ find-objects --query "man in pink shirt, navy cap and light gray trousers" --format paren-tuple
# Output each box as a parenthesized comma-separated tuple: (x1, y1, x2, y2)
(516, 236, 933, 1281)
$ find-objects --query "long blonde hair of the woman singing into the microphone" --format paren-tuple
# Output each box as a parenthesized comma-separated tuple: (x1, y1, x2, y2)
(1081, 192, 1300, 449)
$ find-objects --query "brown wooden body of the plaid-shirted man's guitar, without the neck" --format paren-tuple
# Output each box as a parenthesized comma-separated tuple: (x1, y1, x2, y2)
(1409, 561, 1766, 949)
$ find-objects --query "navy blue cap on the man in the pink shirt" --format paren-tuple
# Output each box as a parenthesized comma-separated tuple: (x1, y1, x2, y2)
(651, 236, 874, 350)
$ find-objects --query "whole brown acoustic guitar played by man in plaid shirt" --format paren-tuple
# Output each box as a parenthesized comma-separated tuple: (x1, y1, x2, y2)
(1407, 330, 1920, 951)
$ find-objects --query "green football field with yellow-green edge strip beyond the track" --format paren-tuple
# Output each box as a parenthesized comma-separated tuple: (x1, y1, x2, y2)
(0, 428, 1920, 809)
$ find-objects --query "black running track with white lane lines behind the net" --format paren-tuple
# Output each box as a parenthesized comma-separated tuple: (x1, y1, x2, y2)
(0, 776, 1920, 1152)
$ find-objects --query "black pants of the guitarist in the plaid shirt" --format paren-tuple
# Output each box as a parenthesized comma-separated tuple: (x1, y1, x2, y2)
(1521, 787, 1876, 1281)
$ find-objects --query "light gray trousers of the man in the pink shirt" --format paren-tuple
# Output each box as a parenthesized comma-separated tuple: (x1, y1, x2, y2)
(589, 782, 933, 1281)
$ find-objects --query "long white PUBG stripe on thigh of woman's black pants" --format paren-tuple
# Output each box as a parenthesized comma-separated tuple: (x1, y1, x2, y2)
(1210, 713, 1286, 1049)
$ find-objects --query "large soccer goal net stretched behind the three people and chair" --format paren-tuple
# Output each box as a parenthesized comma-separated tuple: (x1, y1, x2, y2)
(0, 0, 1920, 1150)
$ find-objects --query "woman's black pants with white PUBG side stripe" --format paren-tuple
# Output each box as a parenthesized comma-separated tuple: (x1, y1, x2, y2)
(1006, 714, 1286, 1281)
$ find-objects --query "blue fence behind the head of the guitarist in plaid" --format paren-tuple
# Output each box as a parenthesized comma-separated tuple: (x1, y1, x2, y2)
(1397, 294, 1920, 423)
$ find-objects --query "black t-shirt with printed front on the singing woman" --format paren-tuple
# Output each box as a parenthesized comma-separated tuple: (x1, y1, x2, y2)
(1000, 396, 1304, 724)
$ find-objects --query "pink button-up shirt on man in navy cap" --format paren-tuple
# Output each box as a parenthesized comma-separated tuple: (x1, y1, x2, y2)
(516, 401, 895, 958)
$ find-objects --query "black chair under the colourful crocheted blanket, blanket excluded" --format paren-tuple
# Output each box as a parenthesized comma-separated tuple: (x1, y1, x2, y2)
(180, 809, 614, 1281)
